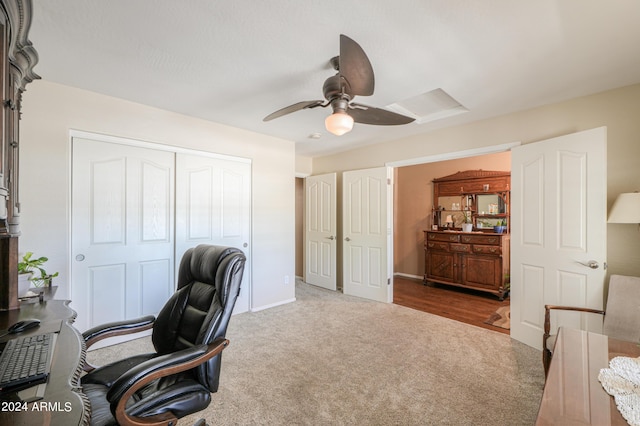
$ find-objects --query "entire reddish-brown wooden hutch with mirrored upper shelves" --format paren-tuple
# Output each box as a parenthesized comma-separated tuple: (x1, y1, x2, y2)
(424, 170, 511, 300)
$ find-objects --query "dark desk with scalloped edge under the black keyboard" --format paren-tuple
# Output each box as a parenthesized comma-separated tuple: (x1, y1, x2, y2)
(0, 300, 91, 426)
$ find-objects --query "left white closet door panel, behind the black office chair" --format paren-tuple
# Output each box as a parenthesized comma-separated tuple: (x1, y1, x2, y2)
(71, 138, 174, 331)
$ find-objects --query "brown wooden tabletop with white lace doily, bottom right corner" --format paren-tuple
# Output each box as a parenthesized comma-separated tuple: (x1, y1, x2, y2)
(536, 327, 640, 426)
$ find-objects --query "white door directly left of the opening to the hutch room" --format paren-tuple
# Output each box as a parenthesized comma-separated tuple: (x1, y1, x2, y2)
(342, 167, 393, 302)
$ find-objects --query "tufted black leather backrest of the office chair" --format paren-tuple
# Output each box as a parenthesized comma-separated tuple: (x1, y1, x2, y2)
(152, 244, 246, 392)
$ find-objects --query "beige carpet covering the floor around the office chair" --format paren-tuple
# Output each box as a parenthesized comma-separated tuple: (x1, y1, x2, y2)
(89, 283, 544, 426)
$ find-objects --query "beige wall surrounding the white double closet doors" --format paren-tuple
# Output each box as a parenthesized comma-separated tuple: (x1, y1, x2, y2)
(20, 80, 295, 310)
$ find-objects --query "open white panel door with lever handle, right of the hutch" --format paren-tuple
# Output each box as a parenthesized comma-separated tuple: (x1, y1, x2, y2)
(511, 128, 607, 349)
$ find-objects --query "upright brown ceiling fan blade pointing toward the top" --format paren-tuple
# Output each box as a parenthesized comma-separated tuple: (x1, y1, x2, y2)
(338, 34, 375, 96)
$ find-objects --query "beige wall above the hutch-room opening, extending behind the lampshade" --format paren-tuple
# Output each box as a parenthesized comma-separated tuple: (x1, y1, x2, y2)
(313, 85, 640, 276)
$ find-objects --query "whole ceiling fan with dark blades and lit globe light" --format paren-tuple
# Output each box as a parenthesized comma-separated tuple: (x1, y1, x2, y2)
(262, 34, 414, 136)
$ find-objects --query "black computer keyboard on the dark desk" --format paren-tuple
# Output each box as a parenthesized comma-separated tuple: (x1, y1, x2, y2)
(0, 333, 57, 393)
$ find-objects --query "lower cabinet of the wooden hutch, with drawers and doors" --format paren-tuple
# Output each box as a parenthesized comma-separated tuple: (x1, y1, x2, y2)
(424, 231, 510, 300)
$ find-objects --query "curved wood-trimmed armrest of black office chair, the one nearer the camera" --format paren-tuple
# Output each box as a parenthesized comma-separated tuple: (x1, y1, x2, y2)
(107, 339, 229, 426)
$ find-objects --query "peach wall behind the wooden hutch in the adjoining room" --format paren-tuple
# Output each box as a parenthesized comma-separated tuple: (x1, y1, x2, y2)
(393, 152, 511, 277)
